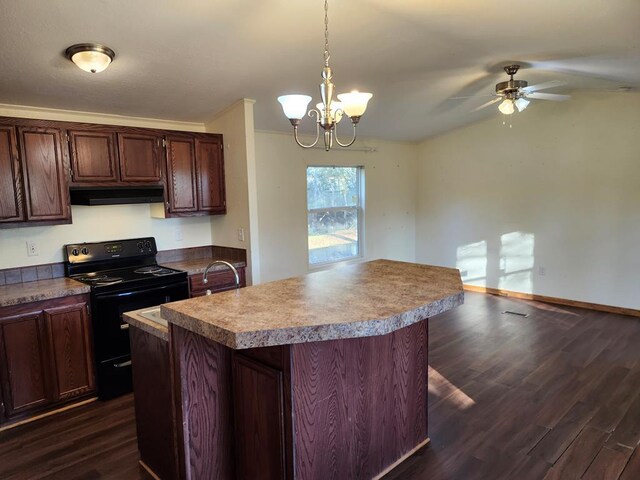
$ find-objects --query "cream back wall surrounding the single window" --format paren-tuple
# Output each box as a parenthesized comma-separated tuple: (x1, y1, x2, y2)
(256, 131, 418, 282)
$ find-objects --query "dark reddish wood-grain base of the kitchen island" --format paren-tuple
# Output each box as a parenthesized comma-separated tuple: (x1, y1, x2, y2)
(170, 319, 428, 480)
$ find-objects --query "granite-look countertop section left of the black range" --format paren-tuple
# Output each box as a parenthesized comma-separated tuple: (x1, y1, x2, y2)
(0, 277, 90, 307)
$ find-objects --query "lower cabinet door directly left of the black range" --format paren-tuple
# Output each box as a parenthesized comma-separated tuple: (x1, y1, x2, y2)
(44, 303, 95, 401)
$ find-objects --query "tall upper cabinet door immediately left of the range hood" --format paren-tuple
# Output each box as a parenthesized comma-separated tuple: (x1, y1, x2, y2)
(18, 127, 71, 223)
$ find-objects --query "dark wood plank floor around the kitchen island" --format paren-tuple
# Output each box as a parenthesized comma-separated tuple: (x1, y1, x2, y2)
(0, 293, 640, 480)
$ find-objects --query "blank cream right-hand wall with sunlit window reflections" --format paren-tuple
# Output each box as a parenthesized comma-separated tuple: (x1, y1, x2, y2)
(416, 92, 640, 309)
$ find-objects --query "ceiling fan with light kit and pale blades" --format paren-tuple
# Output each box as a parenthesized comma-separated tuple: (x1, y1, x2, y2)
(472, 65, 571, 115)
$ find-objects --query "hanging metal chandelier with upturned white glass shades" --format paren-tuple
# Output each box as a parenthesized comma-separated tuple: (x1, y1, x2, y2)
(278, 0, 373, 152)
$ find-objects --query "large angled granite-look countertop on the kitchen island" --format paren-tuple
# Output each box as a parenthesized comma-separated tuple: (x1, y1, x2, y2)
(161, 260, 464, 349)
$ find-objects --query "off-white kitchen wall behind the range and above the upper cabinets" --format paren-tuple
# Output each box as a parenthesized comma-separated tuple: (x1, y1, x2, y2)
(0, 105, 212, 269)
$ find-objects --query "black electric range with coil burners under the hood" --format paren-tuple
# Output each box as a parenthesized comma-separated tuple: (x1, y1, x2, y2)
(64, 237, 189, 400)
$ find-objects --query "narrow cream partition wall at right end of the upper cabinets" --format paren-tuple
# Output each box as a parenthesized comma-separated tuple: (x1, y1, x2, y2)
(205, 99, 259, 285)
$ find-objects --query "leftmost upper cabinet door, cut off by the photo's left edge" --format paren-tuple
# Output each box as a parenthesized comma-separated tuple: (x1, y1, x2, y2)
(0, 127, 24, 222)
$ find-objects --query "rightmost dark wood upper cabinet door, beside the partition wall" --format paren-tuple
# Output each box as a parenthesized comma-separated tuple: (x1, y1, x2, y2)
(196, 135, 227, 213)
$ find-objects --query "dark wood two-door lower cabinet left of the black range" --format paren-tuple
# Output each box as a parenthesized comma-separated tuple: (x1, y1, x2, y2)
(0, 295, 95, 423)
